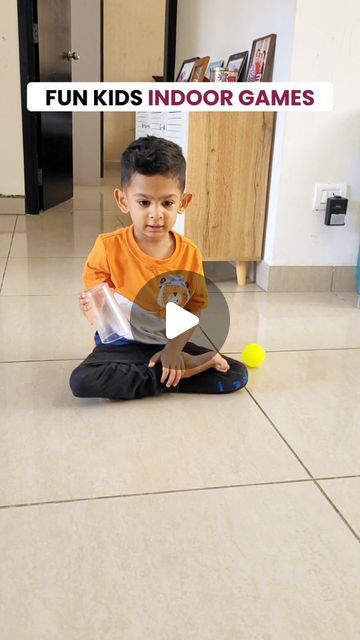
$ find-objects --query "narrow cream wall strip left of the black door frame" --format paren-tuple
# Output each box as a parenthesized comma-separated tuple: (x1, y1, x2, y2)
(0, 0, 25, 196)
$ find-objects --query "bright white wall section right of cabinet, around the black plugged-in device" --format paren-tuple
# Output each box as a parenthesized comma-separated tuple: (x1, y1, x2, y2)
(264, 0, 360, 266)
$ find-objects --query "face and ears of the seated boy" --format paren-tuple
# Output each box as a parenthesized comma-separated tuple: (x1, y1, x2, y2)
(114, 173, 192, 239)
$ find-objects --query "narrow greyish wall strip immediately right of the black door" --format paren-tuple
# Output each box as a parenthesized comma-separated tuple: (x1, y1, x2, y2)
(71, 0, 101, 185)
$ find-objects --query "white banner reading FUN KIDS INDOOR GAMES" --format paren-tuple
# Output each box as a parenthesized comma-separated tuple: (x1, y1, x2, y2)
(27, 82, 333, 111)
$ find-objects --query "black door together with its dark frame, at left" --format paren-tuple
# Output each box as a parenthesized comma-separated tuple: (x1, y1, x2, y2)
(18, 0, 73, 213)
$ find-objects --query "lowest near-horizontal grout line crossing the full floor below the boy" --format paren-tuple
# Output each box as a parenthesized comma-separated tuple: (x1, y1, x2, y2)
(0, 474, 360, 515)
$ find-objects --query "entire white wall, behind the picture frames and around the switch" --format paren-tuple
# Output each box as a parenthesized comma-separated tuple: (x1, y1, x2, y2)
(176, 0, 360, 266)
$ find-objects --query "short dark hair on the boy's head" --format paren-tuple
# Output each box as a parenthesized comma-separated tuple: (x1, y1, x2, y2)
(120, 136, 186, 191)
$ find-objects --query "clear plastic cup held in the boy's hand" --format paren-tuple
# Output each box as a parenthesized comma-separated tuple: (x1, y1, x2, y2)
(84, 283, 131, 344)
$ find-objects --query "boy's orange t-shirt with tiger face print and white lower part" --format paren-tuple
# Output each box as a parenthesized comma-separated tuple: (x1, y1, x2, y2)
(83, 225, 208, 341)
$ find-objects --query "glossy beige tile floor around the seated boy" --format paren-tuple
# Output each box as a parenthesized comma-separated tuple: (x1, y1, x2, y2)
(0, 183, 360, 640)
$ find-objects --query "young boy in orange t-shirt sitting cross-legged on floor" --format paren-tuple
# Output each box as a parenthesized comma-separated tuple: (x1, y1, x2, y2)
(70, 136, 248, 400)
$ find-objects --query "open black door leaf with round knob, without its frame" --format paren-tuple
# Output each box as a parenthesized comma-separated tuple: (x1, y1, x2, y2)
(37, 0, 73, 209)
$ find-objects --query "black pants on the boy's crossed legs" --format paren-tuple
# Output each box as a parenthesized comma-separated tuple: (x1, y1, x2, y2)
(70, 342, 248, 400)
